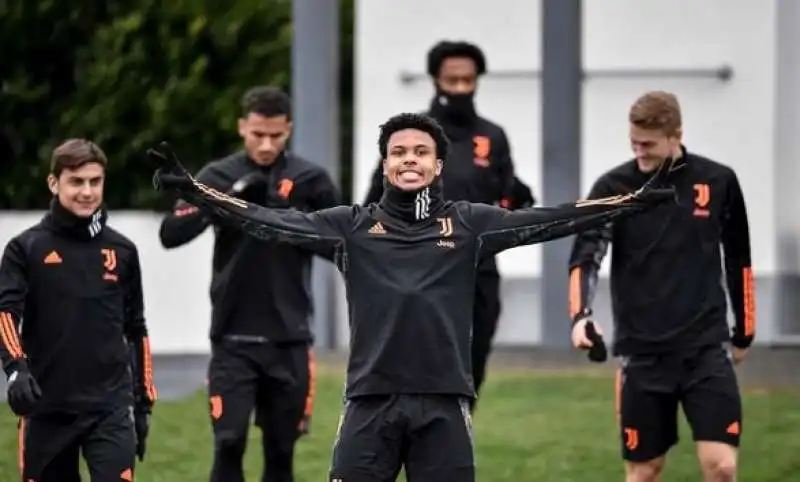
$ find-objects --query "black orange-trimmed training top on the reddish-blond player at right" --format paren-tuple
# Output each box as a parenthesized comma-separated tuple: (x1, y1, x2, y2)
(569, 148, 755, 355)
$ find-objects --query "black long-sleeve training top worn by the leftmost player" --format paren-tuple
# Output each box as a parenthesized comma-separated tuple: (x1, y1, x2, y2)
(0, 203, 156, 413)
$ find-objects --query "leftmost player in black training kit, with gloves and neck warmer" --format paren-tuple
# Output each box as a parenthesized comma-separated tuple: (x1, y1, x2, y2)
(0, 139, 156, 482)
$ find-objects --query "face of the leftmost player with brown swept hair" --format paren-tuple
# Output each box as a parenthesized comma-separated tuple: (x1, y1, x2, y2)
(47, 162, 106, 218)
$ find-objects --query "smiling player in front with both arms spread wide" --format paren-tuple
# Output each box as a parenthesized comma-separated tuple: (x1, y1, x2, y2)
(150, 114, 671, 482)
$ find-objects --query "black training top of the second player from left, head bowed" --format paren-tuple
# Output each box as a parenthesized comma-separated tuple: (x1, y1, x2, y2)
(160, 152, 341, 342)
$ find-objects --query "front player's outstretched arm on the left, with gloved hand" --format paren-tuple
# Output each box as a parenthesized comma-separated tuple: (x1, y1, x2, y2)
(148, 145, 352, 251)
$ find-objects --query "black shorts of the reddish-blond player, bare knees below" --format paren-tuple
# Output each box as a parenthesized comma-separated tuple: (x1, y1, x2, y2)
(617, 345, 742, 462)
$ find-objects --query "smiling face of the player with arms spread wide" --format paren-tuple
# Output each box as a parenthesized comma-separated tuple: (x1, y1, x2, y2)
(383, 129, 442, 191)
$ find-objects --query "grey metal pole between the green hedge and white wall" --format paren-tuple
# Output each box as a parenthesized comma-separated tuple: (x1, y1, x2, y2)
(292, 0, 339, 348)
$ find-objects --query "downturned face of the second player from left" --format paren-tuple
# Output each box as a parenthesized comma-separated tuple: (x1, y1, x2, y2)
(239, 113, 292, 166)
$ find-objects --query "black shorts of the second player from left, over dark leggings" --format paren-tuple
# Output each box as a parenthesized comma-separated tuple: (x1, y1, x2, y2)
(208, 340, 314, 442)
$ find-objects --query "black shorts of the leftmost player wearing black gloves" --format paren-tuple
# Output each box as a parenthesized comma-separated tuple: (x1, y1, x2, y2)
(19, 407, 136, 482)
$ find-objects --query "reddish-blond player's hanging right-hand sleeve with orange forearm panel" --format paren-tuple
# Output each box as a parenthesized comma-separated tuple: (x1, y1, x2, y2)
(722, 174, 756, 348)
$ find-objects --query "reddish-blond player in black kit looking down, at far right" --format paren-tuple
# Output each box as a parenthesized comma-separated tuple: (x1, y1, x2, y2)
(569, 91, 755, 482)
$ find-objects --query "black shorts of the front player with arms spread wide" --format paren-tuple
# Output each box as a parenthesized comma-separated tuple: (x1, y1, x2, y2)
(330, 395, 475, 482)
